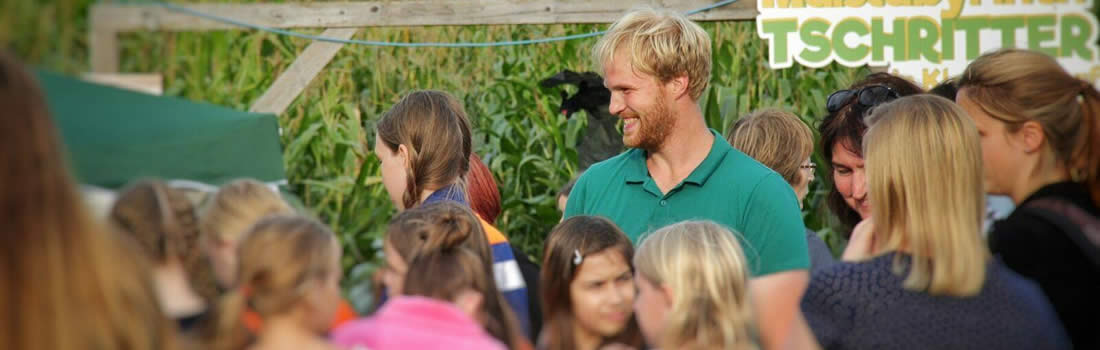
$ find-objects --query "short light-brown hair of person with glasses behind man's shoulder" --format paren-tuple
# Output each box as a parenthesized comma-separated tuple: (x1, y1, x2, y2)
(726, 108, 814, 186)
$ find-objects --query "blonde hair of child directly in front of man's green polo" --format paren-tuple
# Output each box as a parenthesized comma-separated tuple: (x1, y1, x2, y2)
(634, 221, 756, 349)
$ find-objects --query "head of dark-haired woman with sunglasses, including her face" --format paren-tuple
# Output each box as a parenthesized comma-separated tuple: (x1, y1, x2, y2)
(818, 73, 924, 236)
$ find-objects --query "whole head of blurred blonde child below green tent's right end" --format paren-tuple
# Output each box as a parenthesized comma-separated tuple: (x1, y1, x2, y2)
(199, 179, 294, 287)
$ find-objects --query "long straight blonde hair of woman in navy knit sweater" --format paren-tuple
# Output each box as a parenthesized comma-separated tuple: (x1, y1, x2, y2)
(864, 95, 989, 296)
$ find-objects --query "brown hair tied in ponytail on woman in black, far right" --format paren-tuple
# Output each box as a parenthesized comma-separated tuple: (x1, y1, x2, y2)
(958, 48, 1100, 204)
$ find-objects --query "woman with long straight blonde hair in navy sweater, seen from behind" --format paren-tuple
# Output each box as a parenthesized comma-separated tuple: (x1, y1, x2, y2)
(802, 95, 1068, 349)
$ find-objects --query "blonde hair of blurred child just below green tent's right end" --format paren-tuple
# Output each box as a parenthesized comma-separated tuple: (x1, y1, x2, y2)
(199, 179, 294, 242)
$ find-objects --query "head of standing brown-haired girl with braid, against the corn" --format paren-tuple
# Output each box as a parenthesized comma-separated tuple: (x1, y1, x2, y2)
(374, 90, 473, 209)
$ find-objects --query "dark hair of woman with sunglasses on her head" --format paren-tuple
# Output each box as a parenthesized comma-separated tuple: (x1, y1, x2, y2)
(818, 73, 924, 231)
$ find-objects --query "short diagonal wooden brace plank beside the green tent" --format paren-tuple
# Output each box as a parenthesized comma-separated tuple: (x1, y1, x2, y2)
(249, 28, 359, 116)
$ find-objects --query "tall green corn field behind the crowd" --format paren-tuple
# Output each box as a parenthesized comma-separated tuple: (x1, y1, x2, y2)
(0, 0, 867, 304)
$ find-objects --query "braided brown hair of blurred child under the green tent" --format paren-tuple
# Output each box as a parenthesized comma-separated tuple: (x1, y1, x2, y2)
(110, 179, 218, 302)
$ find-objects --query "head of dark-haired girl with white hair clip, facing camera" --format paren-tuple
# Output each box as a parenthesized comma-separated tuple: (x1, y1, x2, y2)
(540, 216, 641, 350)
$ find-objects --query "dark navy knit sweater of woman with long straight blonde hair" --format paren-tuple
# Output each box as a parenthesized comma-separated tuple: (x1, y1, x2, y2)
(802, 253, 1069, 350)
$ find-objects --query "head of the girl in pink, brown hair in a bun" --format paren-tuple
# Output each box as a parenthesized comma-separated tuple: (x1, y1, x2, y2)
(382, 200, 523, 344)
